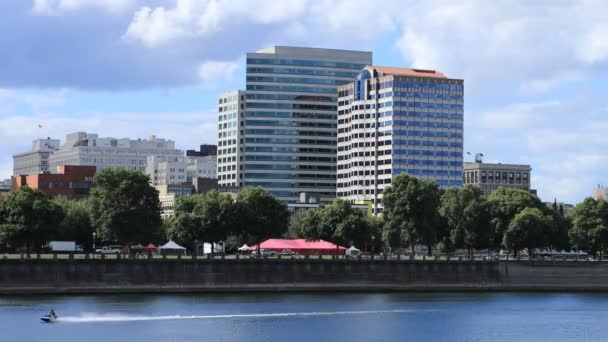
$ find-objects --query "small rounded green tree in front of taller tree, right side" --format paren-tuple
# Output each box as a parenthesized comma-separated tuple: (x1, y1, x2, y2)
(503, 208, 552, 256)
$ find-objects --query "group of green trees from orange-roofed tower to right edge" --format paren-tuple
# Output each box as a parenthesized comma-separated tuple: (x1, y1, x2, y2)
(383, 174, 592, 254)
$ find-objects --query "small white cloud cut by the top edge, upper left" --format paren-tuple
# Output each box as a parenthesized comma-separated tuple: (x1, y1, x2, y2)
(32, 0, 136, 15)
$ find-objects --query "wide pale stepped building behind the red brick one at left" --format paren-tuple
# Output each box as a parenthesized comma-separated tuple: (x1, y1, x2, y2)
(50, 132, 183, 172)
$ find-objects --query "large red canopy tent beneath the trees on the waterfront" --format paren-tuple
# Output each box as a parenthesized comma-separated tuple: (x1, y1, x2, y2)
(251, 239, 346, 255)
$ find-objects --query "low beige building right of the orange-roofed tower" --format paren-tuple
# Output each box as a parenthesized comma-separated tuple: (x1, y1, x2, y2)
(462, 161, 535, 196)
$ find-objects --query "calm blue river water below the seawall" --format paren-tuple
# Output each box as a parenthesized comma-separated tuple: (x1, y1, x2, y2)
(0, 294, 608, 342)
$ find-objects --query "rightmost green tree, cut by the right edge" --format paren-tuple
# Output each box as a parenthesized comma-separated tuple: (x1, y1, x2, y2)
(568, 197, 608, 257)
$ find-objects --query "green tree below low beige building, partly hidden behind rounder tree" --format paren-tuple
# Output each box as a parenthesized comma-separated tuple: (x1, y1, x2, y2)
(487, 187, 547, 248)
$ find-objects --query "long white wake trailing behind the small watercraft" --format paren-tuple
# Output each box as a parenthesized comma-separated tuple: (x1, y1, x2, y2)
(57, 310, 420, 323)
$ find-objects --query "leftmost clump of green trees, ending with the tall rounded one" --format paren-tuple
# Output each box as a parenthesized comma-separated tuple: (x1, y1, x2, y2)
(0, 169, 163, 251)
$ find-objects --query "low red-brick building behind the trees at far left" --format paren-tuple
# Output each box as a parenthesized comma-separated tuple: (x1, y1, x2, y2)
(12, 165, 96, 199)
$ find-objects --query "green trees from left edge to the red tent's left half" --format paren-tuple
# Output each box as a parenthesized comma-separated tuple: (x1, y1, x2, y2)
(0, 169, 289, 251)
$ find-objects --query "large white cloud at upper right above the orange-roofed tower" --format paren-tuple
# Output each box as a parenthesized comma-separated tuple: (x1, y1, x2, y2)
(396, 0, 608, 92)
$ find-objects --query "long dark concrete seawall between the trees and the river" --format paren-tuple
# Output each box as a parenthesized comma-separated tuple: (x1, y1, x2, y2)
(0, 259, 608, 294)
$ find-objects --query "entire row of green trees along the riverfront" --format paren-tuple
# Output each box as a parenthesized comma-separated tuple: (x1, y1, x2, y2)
(0, 169, 608, 255)
